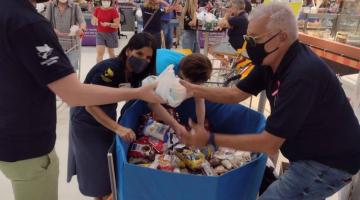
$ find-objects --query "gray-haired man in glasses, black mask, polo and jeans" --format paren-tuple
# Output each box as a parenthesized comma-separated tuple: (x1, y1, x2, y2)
(182, 3, 360, 200)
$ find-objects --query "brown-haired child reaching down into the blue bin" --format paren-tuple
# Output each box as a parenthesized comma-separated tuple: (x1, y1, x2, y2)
(149, 53, 212, 136)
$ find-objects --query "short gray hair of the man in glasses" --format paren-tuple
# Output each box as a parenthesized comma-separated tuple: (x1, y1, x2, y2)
(249, 2, 298, 42)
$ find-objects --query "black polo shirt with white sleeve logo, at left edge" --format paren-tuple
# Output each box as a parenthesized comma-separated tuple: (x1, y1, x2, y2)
(0, 0, 74, 161)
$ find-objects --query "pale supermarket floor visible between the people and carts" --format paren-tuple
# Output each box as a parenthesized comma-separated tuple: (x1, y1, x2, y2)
(0, 33, 338, 200)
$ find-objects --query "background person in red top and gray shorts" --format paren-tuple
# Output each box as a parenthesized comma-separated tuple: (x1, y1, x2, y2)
(91, 0, 120, 63)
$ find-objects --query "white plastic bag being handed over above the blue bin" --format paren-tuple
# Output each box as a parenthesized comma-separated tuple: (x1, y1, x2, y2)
(155, 65, 186, 107)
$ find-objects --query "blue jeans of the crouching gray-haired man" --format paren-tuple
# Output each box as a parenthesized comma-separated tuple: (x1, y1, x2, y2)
(259, 161, 352, 200)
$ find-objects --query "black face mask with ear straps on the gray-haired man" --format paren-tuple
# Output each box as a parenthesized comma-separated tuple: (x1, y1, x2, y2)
(246, 32, 280, 65)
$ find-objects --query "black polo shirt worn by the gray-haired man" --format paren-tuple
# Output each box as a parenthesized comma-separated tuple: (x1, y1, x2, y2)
(237, 41, 360, 174)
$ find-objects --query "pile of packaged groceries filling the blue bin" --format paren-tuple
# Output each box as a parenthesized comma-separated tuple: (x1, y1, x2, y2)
(128, 109, 251, 176)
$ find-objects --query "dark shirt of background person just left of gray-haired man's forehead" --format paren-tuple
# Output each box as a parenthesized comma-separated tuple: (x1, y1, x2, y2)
(228, 11, 249, 49)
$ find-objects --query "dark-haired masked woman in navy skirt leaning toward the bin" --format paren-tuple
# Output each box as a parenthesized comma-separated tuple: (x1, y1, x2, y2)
(67, 33, 156, 200)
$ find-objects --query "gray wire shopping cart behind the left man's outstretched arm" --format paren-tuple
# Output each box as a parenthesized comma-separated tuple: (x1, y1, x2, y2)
(56, 36, 81, 109)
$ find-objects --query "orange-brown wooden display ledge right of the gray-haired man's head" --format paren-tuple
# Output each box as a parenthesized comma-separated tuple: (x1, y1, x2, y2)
(299, 33, 360, 70)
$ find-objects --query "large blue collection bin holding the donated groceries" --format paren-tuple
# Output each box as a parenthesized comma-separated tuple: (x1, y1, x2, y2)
(116, 99, 267, 200)
